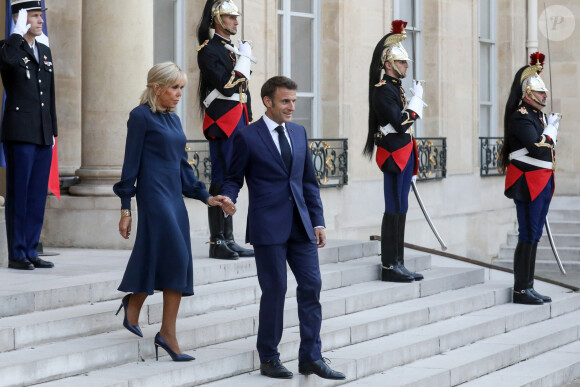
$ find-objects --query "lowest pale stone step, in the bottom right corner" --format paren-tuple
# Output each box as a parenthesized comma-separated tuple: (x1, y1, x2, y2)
(464, 341, 580, 387)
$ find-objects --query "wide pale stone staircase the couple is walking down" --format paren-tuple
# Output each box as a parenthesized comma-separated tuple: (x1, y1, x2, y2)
(0, 241, 580, 387)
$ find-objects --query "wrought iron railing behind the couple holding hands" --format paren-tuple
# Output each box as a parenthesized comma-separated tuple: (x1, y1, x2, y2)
(186, 138, 348, 188)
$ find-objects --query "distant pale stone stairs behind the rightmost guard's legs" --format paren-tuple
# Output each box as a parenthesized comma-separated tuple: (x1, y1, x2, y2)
(493, 196, 580, 273)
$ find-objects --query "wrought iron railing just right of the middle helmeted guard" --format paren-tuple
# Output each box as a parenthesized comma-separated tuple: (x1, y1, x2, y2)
(415, 137, 447, 180)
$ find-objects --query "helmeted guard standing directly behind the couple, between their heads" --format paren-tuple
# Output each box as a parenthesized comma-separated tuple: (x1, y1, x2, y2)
(197, 0, 254, 259)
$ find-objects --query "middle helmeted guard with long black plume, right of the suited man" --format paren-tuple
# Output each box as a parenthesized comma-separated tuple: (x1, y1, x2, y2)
(363, 20, 423, 282)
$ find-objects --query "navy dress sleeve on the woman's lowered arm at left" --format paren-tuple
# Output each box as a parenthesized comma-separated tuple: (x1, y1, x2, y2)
(113, 108, 147, 210)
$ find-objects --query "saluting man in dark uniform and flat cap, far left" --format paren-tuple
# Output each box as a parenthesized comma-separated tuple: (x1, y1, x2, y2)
(0, 0, 57, 270)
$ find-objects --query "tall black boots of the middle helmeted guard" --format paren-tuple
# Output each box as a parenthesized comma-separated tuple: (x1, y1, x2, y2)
(381, 213, 414, 282)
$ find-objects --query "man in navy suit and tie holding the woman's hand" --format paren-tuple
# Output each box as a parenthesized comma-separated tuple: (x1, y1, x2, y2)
(222, 76, 345, 379)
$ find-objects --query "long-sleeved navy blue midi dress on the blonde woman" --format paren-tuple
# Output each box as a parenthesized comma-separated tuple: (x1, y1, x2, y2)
(113, 105, 209, 296)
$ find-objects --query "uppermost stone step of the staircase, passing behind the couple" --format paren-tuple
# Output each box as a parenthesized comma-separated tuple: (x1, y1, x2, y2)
(0, 240, 379, 318)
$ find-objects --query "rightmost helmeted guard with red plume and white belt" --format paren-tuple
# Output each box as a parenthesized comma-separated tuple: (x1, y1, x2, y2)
(500, 52, 561, 305)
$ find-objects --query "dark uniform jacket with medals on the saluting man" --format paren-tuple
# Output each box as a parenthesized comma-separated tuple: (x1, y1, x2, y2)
(0, 34, 58, 145)
